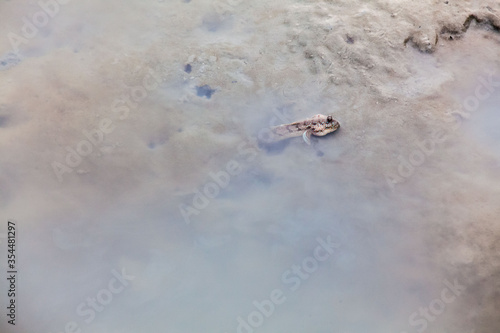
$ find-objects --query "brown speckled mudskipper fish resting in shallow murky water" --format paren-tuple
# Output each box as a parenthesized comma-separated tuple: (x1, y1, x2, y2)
(271, 114, 340, 145)
